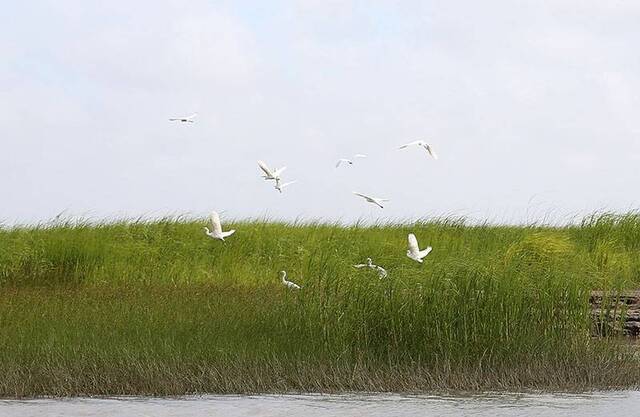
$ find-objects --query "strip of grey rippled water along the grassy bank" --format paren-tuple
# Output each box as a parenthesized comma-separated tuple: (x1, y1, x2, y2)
(0, 391, 640, 417)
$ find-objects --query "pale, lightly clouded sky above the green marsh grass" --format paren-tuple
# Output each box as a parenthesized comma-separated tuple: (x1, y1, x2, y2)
(0, 0, 640, 225)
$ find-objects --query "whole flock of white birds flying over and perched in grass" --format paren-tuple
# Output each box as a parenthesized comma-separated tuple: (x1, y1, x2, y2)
(169, 113, 438, 290)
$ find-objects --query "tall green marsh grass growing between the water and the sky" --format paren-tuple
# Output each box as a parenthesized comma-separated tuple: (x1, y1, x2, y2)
(0, 214, 640, 396)
